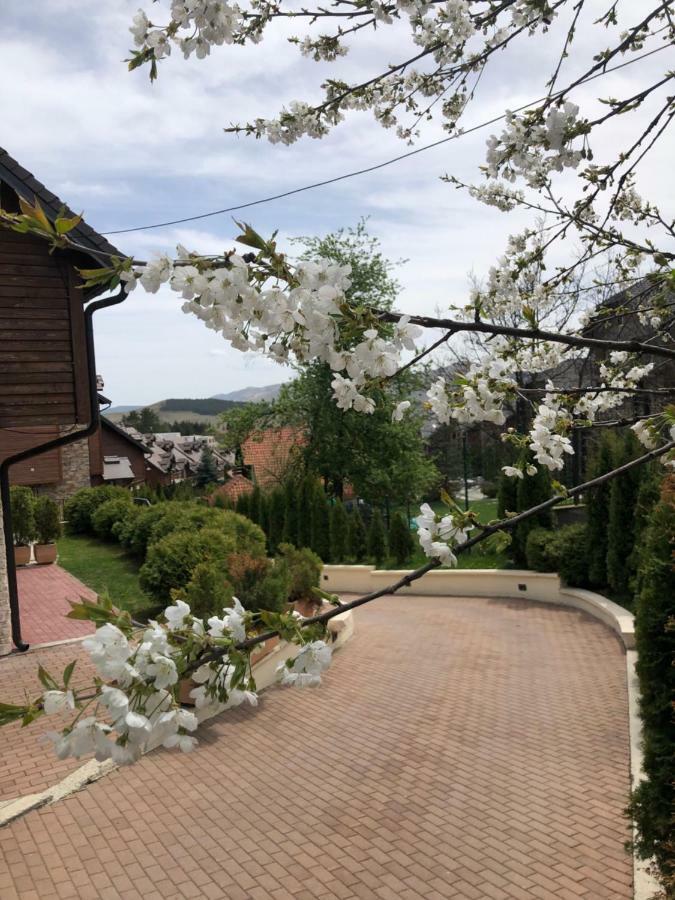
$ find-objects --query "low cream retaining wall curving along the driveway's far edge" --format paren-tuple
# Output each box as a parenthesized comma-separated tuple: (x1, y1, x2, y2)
(322, 566, 635, 650)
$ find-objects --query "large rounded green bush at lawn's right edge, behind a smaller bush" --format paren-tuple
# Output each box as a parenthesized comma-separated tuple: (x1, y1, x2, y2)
(139, 528, 239, 604)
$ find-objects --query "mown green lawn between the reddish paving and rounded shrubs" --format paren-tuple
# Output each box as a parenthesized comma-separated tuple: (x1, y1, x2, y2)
(58, 535, 151, 612)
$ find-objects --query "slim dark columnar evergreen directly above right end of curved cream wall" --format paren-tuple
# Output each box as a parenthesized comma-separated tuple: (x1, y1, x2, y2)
(607, 433, 642, 606)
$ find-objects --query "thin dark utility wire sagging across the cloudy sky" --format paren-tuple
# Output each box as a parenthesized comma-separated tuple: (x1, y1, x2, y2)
(100, 44, 670, 237)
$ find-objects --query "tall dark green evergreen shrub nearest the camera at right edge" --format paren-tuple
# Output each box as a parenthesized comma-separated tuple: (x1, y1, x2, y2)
(632, 498, 675, 884)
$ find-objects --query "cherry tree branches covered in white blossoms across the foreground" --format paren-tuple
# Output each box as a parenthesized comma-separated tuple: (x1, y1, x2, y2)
(0, 0, 675, 763)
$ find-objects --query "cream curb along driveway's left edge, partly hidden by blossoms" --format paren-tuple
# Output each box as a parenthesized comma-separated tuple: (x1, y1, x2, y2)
(0, 610, 354, 828)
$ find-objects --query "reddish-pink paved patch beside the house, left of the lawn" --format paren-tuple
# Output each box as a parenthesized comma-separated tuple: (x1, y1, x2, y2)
(16, 565, 96, 644)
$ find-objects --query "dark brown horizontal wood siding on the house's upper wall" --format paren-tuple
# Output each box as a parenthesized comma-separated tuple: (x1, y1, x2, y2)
(0, 231, 89, 429)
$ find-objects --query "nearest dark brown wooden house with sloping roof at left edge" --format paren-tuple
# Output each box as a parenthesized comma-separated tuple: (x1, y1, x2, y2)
(0, 149, 124, 654)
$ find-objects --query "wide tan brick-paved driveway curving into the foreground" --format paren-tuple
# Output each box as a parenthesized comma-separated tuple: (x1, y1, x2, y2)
(0, 597, 631, 900)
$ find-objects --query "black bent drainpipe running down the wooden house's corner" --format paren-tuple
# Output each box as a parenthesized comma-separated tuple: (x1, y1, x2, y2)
(0, 287, 126, 653)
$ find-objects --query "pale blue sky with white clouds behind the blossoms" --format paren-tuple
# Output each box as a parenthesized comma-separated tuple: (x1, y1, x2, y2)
(0, 0, 674, 404)
